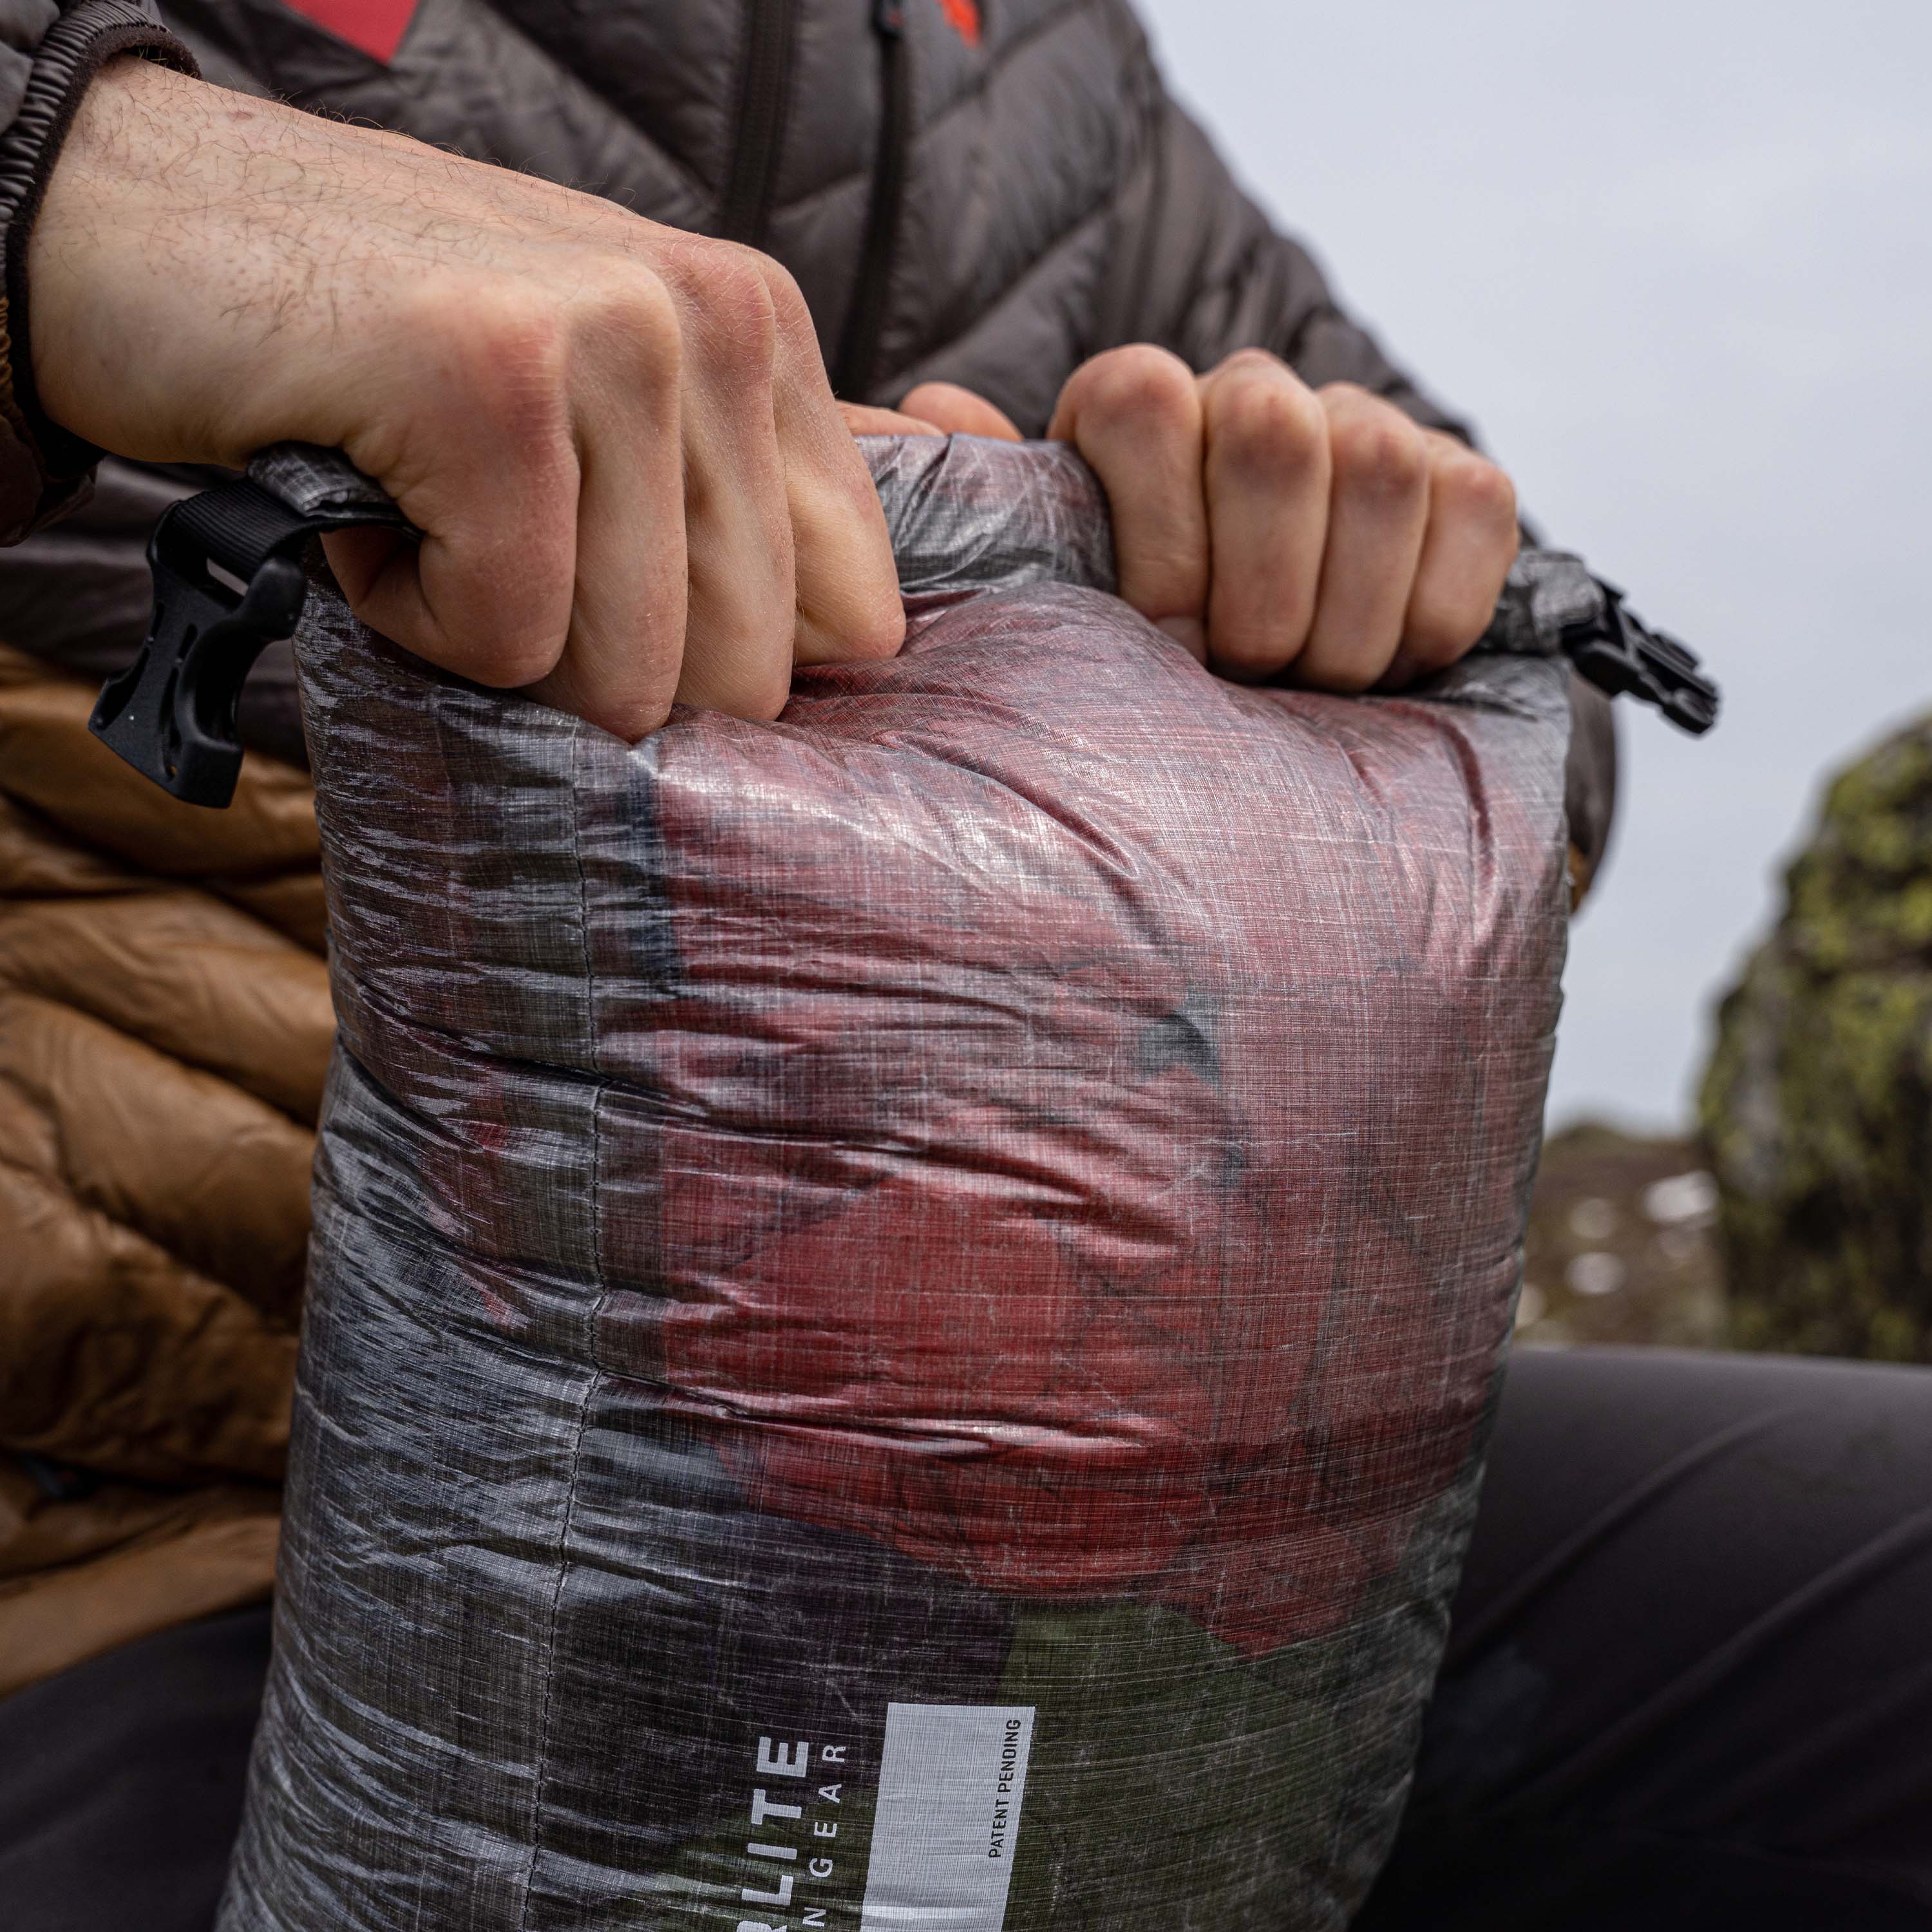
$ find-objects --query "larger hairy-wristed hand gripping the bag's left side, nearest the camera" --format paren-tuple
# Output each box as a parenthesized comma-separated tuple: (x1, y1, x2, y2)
(29, 60, 904, 738)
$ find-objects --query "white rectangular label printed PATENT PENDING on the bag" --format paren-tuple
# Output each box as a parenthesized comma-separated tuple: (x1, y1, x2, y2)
(860, 1704, 1034, 1932)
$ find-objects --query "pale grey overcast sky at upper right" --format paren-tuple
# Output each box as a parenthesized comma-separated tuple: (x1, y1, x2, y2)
(1142, 0, 1932, 1124)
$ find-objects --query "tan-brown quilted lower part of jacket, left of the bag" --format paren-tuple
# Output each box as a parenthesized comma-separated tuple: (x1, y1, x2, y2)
(0, 647, 334, 1694)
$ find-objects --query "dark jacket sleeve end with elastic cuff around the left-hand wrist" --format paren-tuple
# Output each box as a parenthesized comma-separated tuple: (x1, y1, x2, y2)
(0, 0, 195, 543)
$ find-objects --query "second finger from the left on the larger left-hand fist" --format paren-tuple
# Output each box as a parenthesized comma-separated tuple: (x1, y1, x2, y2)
(527, 284, 690, 742)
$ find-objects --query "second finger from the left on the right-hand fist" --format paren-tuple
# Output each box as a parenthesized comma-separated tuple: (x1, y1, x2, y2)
(1202, 350, 1329, 678)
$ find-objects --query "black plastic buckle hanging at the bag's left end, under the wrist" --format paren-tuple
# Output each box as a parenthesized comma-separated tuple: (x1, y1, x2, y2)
(89, 498, 309, 808)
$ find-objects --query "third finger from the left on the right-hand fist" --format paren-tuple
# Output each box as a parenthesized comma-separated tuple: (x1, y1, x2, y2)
(1294, 383, 1430, 692)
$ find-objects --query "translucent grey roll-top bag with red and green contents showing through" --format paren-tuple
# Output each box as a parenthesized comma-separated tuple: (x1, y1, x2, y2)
(222, 439, 1569, 1932)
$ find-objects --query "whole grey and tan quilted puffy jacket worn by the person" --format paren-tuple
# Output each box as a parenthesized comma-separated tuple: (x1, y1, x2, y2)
(0, 0, 1609, 1689)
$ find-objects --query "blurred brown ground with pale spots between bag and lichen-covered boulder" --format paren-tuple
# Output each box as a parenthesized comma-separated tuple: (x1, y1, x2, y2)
(1517, 1122, 1725, 1349)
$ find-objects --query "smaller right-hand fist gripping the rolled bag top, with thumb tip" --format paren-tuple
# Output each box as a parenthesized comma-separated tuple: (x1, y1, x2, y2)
(862, 344, 1517, 692)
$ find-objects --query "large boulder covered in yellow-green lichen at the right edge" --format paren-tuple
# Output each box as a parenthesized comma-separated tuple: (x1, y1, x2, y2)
(1700, 719, 1932, 1362)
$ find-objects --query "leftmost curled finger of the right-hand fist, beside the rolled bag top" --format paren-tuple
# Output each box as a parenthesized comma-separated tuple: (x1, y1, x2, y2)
(1047, 342, 1208, 657)
